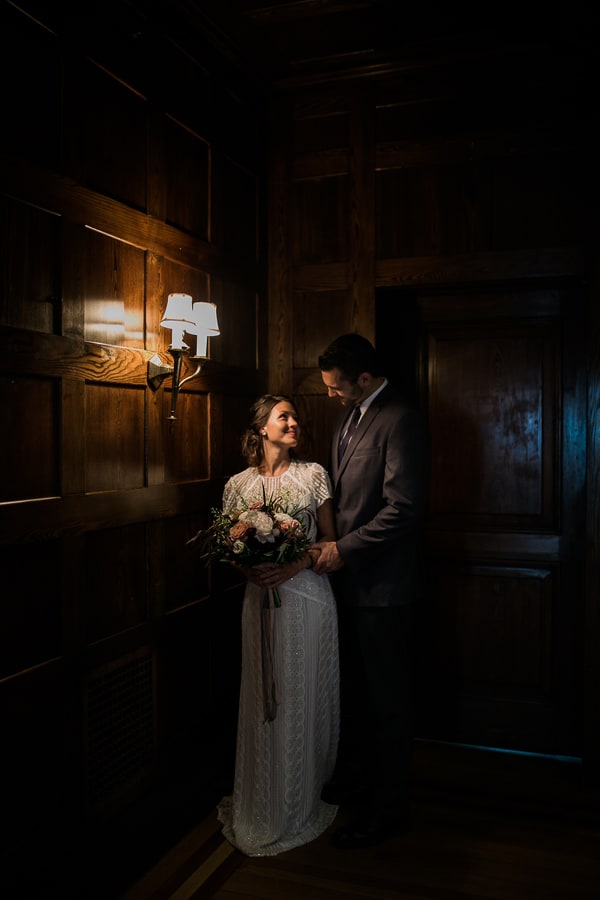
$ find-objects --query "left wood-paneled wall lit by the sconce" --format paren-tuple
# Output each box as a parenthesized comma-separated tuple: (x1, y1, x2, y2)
(0, 2, 266, 839)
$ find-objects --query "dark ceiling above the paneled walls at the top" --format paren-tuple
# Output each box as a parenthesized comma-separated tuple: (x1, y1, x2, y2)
(152, 0, 596, 87)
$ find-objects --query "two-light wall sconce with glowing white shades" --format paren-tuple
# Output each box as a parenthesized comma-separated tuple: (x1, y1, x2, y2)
(148, 294, 221, 419)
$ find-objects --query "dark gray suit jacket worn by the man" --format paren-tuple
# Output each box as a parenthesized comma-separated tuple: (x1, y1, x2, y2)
(330, 385, 430, 606)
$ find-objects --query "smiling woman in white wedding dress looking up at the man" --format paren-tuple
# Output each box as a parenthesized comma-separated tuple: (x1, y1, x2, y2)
(218, 394, 340, 856)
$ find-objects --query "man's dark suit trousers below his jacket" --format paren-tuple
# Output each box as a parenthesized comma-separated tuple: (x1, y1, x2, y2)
(337, 604, 414, 816)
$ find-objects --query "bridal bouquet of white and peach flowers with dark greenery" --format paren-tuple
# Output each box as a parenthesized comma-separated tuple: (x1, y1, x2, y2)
(187, 492, 311, 606)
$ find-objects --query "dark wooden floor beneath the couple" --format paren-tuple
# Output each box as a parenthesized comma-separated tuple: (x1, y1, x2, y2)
(8, 745, 600, 900)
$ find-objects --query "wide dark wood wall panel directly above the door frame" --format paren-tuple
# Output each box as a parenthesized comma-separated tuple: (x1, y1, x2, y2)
(377, 148, 585, 258)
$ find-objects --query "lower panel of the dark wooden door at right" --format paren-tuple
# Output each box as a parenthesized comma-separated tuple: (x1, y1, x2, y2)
(418, 562, 556, 756)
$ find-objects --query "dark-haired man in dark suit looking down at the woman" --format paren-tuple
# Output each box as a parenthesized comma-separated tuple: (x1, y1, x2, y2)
(314, 334, 430, 849)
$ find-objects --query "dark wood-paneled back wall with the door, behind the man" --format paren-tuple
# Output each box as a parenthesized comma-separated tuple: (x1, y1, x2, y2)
(269, 42, 600, 776)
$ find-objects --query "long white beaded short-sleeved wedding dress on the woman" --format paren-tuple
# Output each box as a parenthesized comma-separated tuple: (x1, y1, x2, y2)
(218, 460, 340, 856)
